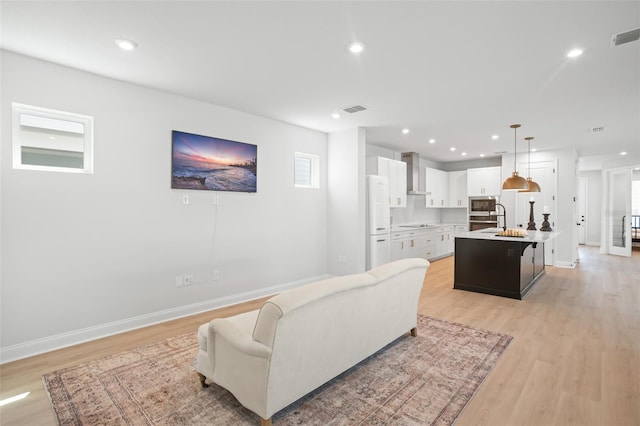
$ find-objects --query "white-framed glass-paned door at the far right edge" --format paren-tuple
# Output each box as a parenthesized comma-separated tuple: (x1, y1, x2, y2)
(607, 169, 631, 257)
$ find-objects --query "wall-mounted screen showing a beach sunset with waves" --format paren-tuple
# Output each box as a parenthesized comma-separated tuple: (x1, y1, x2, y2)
(171, 130, 258, 192)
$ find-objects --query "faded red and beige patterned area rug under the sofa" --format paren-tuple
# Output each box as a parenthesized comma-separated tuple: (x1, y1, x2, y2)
(43, 316, 512, 426)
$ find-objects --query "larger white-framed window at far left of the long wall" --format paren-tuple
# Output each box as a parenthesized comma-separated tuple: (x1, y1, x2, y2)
(12, 103, 93, 173)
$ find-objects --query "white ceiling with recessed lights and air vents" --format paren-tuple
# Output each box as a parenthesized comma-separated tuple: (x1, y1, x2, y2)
(0, 0, 640, 167)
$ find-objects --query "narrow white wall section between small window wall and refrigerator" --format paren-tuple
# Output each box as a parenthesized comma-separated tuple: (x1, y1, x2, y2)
(327, 129, 366, 275)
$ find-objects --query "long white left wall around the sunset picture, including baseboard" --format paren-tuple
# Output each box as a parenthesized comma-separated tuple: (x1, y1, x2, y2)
(0, 51, 330, 362)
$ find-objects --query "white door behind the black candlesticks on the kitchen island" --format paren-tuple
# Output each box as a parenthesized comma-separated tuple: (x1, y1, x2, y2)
(515, 161, 556, 265)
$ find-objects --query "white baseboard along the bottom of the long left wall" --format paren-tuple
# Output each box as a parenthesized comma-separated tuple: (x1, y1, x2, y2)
(0, 275, 327, 364)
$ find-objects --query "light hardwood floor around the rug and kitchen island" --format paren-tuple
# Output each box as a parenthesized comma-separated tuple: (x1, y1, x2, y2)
(0, 247, 640, 426)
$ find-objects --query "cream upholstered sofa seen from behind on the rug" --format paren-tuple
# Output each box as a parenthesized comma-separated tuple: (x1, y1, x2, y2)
(197, 258, 429, 425)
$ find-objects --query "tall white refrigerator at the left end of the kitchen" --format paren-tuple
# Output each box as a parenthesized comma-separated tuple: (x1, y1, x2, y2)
(367, 175, 391, 269)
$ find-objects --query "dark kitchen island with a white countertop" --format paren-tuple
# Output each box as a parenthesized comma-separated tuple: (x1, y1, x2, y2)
(453, 228, 559, 299)
